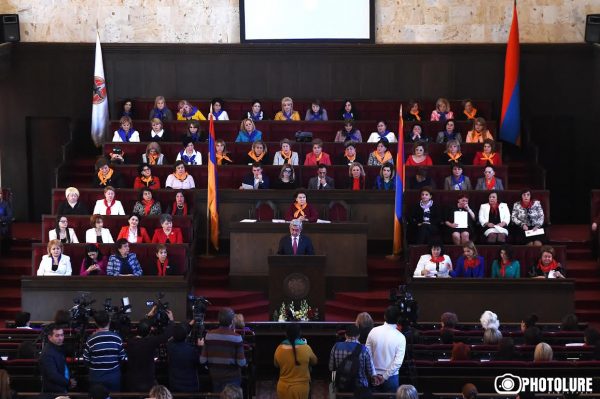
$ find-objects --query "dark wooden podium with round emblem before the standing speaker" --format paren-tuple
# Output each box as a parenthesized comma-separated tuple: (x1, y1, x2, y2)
(268, 255, 327, 319)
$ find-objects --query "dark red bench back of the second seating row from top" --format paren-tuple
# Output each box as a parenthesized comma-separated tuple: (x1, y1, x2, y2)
(106, 117, 497, 142)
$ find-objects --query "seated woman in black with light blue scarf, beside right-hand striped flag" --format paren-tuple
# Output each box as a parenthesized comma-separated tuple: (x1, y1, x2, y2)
(409, 187, 442, 244)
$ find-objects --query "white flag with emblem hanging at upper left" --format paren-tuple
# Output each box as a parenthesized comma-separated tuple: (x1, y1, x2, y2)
(92, 31, 109, 147)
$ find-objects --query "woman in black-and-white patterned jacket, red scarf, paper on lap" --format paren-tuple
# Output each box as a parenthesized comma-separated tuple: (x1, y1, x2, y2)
(511, 189, 546, 246)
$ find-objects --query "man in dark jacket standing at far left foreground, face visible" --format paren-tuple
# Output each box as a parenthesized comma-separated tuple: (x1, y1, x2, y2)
(39, 324, 77, 393)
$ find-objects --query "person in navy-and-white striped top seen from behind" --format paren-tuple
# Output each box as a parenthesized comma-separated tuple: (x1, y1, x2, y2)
(83, 310, 127, 392)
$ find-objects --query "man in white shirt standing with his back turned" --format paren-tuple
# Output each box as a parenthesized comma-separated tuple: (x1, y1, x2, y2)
(367, 306, 406, 392)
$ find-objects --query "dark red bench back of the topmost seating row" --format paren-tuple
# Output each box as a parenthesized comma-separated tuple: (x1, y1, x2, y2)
(125, 98, 493, 120)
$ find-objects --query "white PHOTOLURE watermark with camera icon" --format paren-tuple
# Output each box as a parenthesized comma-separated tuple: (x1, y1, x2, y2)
(494, 373, 592, 395)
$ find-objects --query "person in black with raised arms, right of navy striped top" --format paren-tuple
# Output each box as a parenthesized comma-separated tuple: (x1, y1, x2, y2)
(126, 299, 175, 392)
